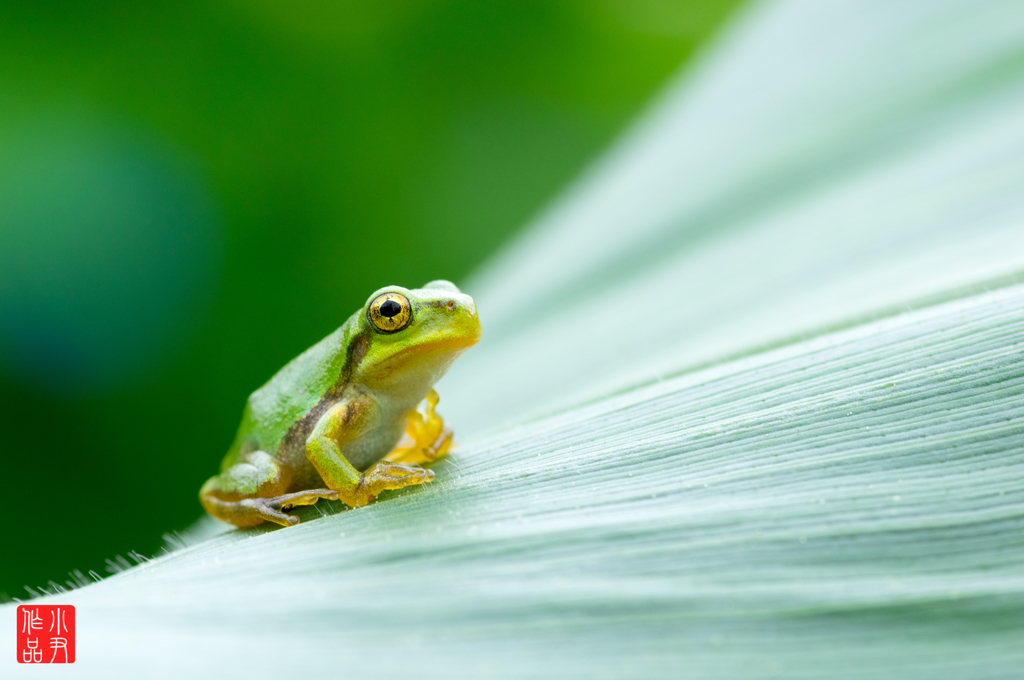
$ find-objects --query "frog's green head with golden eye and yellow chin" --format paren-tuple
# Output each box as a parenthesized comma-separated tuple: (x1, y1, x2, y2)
(357, 281, 480, 392)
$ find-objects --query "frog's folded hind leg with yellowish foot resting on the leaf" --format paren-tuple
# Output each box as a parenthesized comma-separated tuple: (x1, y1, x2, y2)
(199, 451, 338, 526)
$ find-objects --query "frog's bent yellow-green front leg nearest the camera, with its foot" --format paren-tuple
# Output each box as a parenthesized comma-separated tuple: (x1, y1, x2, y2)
(306, 399, 434, 508)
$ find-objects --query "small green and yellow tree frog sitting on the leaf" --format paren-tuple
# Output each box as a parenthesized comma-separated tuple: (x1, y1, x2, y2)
(200, 281, 481, 527)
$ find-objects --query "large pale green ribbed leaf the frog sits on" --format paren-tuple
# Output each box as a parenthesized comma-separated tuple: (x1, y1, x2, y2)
(4, 0, 1024, 678)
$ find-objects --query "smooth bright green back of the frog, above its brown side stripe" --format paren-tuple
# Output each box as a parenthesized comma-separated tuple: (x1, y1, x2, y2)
(221, 318, 355, 470)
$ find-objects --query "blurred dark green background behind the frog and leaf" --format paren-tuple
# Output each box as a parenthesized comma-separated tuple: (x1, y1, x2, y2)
(0, 0, 737, 597)
